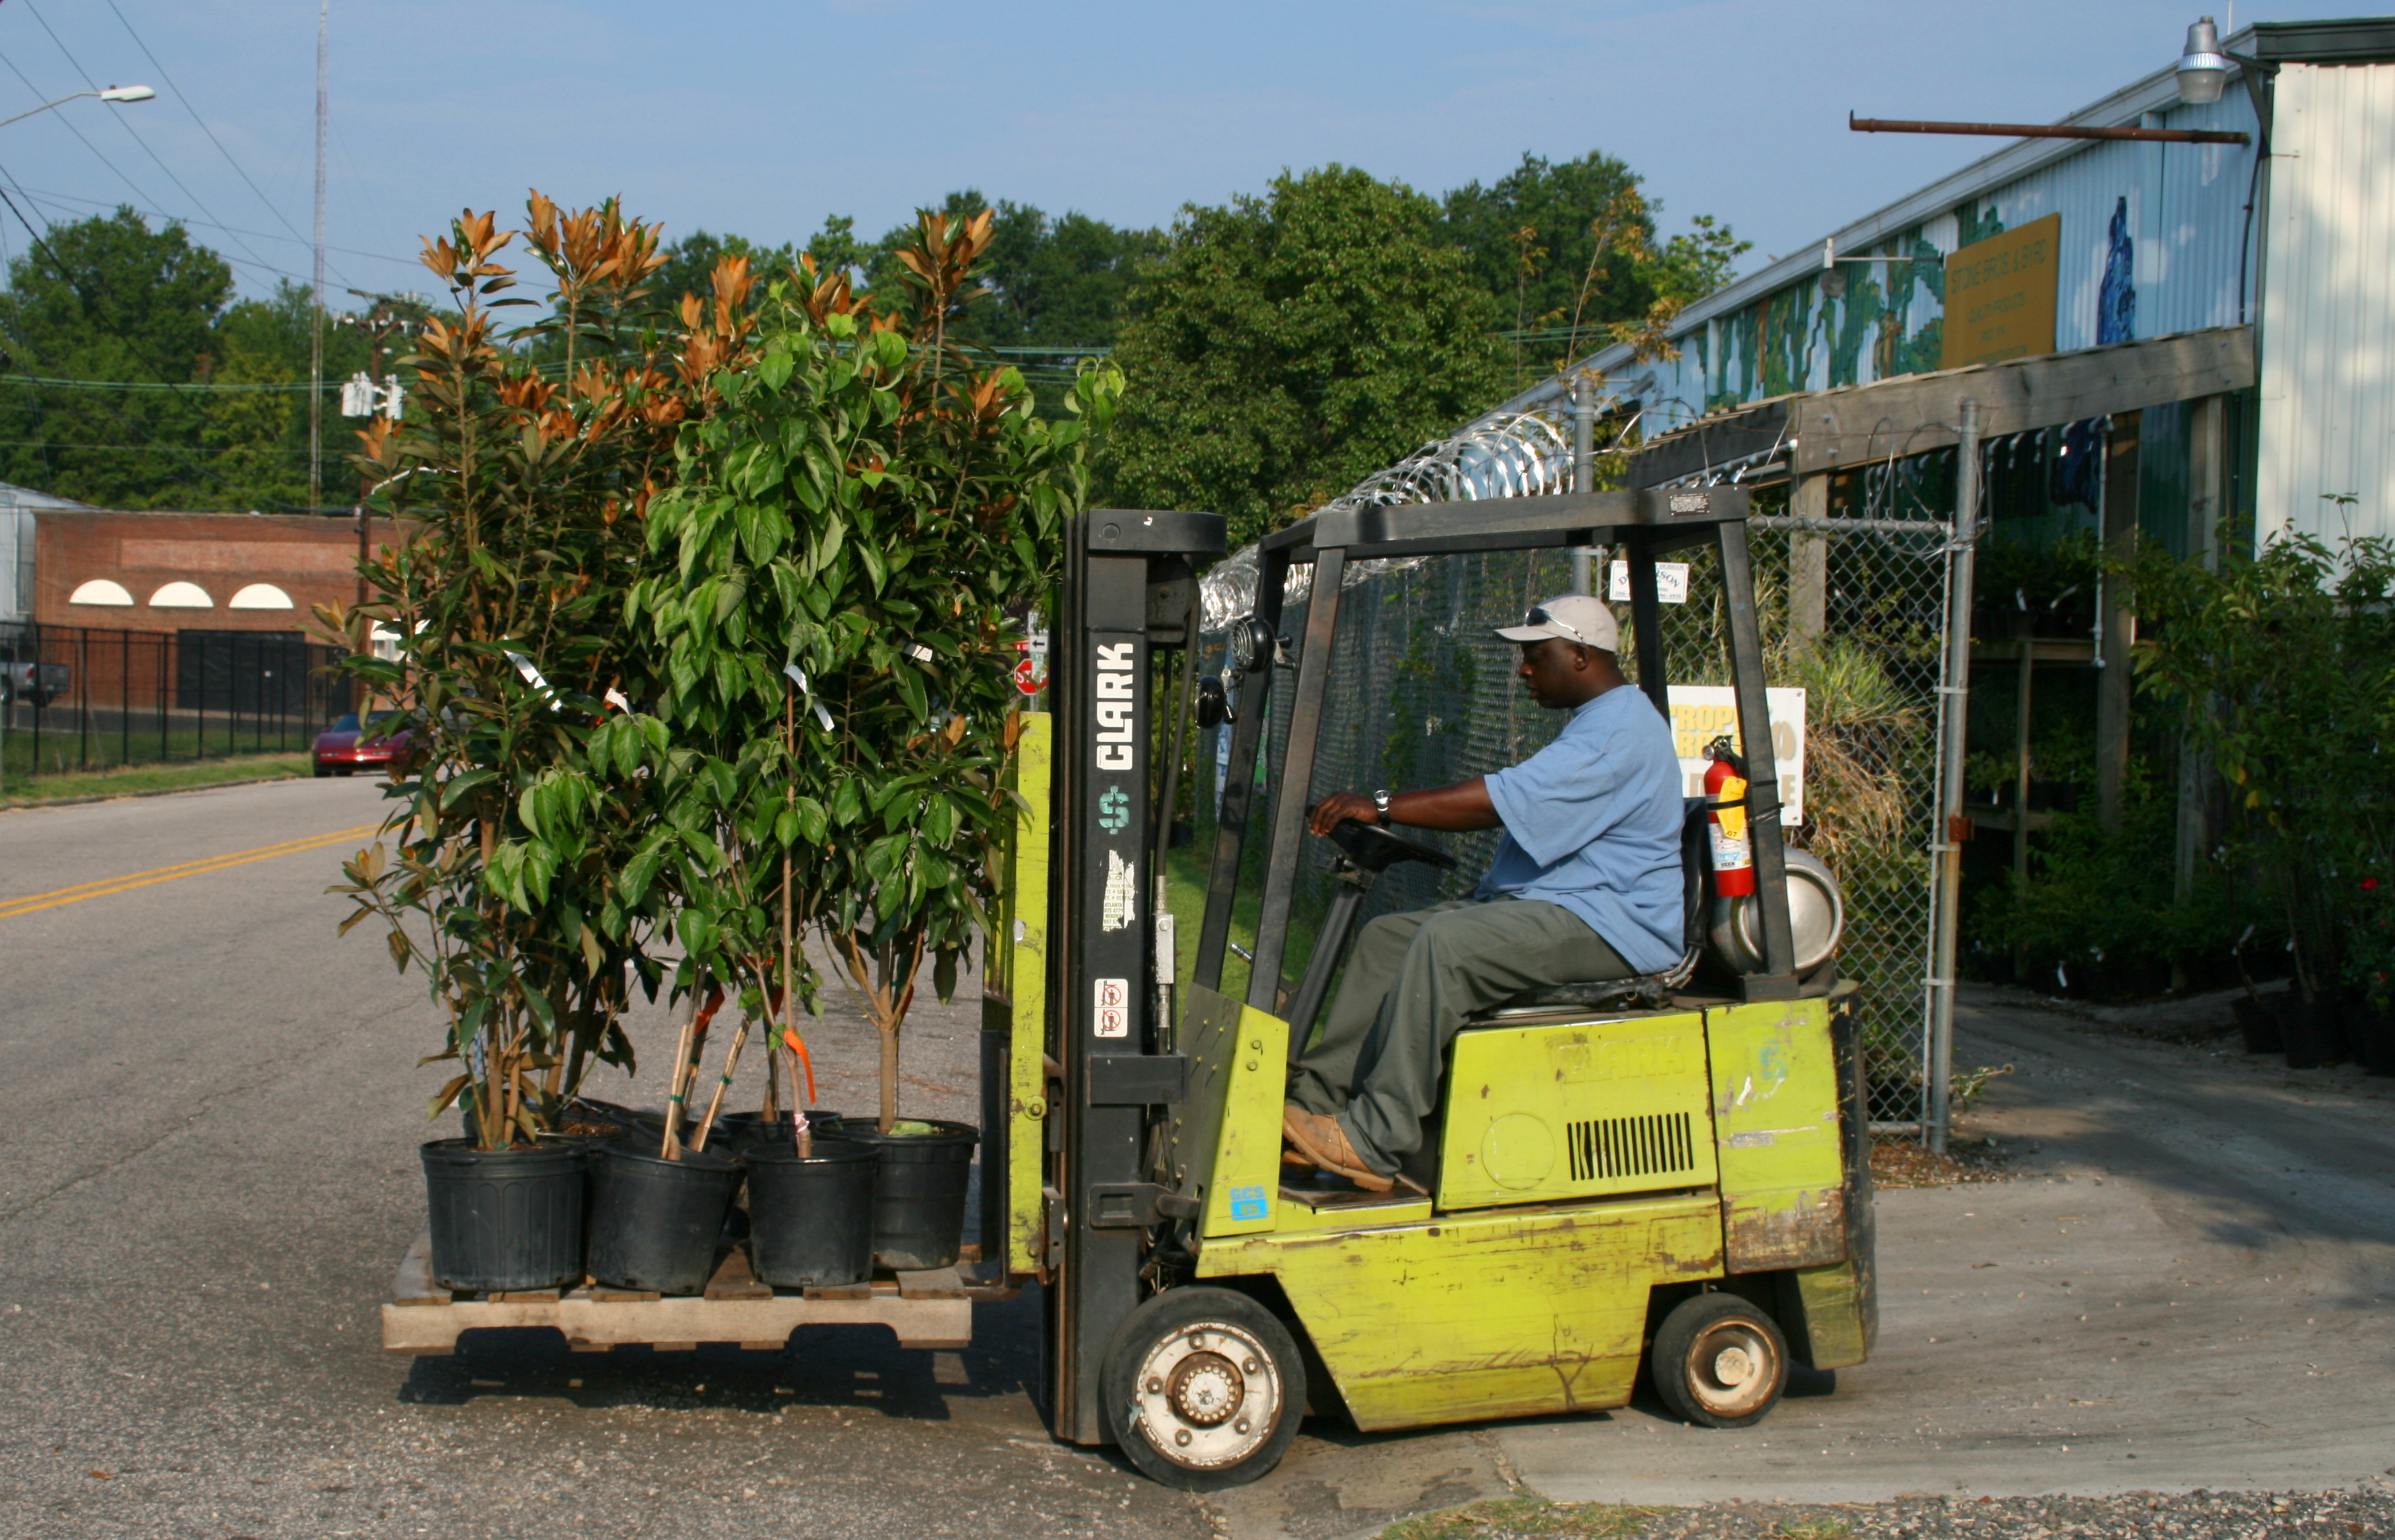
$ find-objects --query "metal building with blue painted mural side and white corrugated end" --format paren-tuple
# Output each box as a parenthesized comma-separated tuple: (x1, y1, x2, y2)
(1485, 17, 2395, 551)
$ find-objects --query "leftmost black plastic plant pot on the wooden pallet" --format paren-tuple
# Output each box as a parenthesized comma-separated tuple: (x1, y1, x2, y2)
(416, 1140, 589, 1293)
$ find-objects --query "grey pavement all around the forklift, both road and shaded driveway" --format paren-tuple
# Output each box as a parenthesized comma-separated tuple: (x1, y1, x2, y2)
(0, 781, 2395, 1540)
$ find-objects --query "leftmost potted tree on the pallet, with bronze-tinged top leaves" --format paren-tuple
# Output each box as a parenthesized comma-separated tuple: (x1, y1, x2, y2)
(324, 194, 711, 1288)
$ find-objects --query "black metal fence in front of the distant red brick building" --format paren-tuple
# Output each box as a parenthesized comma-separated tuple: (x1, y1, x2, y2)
(0, 623, 350, 786)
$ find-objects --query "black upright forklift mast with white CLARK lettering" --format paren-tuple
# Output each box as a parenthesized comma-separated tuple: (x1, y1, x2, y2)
(1049, 508, 1224, 1444)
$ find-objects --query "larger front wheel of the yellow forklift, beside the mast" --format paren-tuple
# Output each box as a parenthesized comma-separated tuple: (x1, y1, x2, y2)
(1097, 1288, 1305, 1492)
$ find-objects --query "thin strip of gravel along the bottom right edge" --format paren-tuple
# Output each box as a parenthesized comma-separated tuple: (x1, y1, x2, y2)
(1385, 1490, 2395, 1540)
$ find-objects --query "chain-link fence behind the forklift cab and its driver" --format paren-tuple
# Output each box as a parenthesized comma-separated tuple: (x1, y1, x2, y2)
(1200, 512, 1950, 1124)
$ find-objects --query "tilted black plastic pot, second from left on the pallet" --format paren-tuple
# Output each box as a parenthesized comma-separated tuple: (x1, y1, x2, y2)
(589, 1140, 740, 1293)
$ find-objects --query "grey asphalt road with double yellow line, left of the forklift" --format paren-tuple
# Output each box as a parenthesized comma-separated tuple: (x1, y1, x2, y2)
(0, 778, 1212, 1540)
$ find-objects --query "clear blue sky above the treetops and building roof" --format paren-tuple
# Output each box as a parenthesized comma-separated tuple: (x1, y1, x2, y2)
(0, 0, 2354, 316)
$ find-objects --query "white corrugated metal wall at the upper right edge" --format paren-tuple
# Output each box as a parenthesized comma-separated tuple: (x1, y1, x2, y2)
(2256, 65, 2395, 542)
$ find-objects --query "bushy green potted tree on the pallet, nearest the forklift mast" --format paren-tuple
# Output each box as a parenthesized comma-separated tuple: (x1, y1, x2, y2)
(632, 211, 1119, 1267)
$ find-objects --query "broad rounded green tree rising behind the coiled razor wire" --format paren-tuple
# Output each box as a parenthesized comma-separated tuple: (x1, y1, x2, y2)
(1109, 166, 1506, 546)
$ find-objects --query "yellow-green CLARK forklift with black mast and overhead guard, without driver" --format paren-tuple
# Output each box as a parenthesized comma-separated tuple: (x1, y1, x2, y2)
(982, 488, 1878, 1490)
